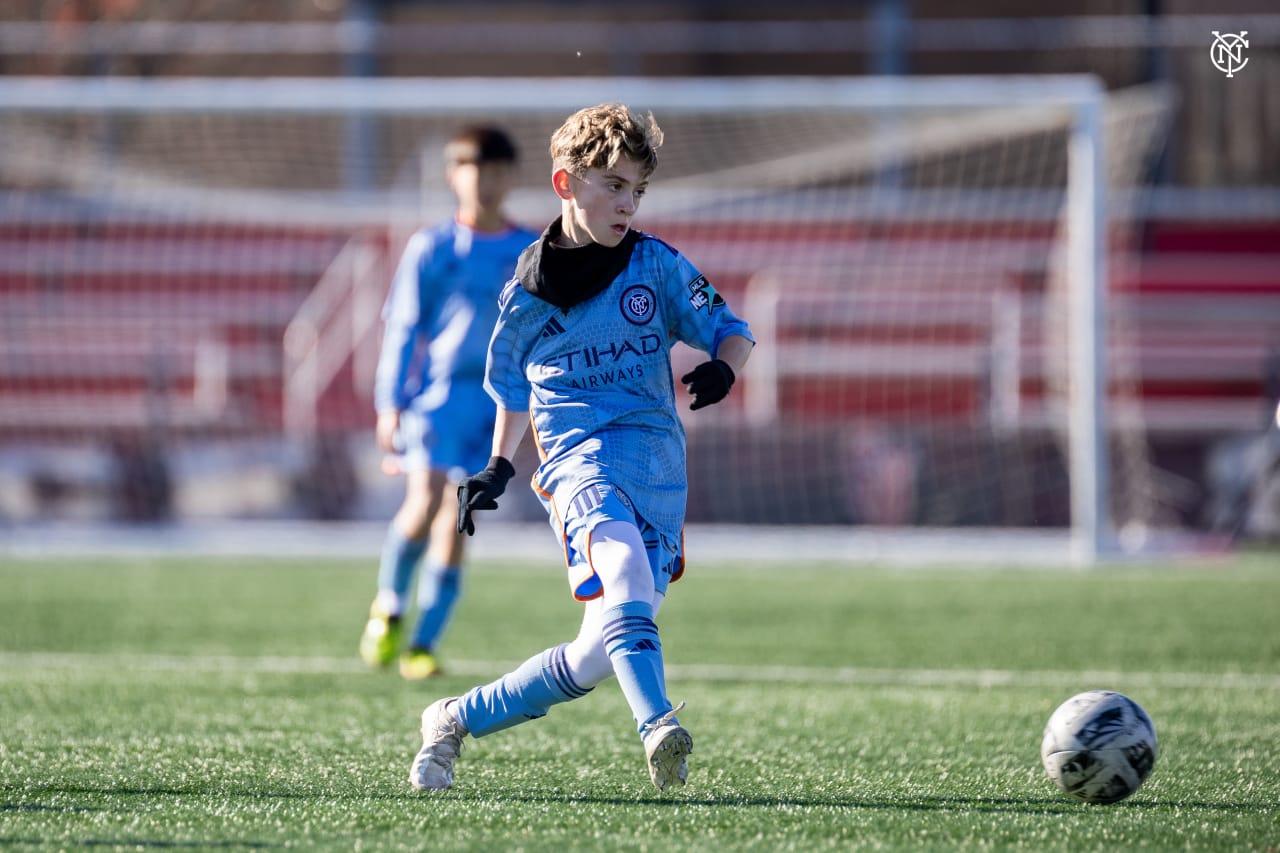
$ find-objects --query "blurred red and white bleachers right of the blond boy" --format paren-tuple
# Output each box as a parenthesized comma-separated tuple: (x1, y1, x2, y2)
(691, 212, 1280, 441)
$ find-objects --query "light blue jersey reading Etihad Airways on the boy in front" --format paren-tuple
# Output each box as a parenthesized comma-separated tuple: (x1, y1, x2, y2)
(485, 233, 750, 542)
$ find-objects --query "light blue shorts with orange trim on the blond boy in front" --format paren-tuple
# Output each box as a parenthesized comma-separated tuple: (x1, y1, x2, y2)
(539, 483, 685, 601)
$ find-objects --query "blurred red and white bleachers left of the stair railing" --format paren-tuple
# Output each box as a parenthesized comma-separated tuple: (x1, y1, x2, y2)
(0, 222, 342, 442)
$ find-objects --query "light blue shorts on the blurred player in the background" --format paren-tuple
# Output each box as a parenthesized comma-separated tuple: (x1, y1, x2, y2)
(397, 380, 497, 482)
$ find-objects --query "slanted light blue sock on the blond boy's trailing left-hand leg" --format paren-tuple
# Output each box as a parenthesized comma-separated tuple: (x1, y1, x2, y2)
(453, 643, 591, 738)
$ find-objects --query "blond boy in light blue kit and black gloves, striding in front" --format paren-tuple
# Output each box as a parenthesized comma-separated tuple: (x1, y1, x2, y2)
(410, 104, 754, 790)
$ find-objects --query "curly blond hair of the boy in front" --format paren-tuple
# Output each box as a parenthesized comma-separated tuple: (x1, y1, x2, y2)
(550, 104, 662, 178)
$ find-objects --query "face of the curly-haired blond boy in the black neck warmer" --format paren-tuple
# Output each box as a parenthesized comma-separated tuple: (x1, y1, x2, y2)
(552, 158, 649, 247)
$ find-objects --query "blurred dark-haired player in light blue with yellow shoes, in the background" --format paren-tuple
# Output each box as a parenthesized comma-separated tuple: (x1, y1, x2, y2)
(360, 127, 538, 679)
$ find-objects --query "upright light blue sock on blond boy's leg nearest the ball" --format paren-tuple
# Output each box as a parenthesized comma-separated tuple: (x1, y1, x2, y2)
(603, 601, 671, 730)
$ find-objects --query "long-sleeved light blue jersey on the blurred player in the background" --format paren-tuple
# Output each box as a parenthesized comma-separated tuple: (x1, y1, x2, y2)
(374, 220, 538, 412)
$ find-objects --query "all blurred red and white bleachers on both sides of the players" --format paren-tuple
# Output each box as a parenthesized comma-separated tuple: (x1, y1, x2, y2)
(0, 213, 1280, 439)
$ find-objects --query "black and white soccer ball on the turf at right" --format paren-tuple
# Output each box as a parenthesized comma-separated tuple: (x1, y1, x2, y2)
(1041, 690, 1156, 803)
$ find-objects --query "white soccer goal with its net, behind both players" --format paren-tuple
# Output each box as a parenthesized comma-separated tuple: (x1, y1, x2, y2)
(0, 77, 1170, 558)
